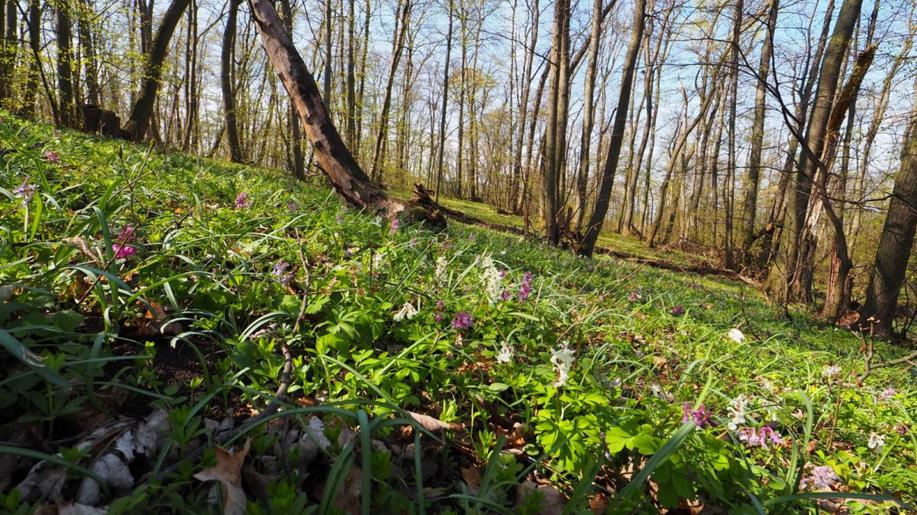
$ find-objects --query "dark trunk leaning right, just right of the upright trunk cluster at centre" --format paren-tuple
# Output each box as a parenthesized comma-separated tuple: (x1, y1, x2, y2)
(579, 0, 649, 256)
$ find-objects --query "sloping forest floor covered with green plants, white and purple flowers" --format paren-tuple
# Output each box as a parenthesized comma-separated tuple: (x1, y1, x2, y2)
(0, 112, 917, 514)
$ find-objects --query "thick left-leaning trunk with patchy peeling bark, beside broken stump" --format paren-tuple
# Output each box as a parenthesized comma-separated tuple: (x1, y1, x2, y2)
(249, 0, 390, 211)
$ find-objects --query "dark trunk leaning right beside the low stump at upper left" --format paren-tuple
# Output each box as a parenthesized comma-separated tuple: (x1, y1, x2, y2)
(126, 0, 191, 141)
